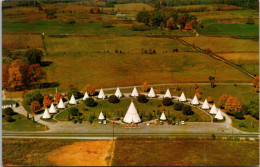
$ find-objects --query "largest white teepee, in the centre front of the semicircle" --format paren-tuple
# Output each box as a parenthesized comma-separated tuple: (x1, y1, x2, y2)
(124, 102, 141, 123)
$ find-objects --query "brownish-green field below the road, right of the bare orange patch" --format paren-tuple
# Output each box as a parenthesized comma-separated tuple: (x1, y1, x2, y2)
(112, 138, 259, 166)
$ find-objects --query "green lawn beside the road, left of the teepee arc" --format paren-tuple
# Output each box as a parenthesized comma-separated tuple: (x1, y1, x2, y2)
(2, 114, 48, 132)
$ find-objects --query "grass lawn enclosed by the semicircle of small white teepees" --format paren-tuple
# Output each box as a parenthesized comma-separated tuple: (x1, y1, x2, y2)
(55, 98, 211, 122)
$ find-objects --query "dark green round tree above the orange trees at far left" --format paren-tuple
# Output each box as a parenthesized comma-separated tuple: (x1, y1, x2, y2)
(25, 49, 43, 64)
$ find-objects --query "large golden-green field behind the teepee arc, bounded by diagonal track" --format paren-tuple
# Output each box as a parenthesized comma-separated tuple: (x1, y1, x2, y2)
(44, 37, 251, 90)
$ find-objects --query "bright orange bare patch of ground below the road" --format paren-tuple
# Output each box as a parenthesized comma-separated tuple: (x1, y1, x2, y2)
(48, 140, 113, 166)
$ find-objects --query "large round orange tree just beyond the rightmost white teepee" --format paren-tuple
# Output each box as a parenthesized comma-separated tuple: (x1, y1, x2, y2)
(225, 96, 242, 115)
